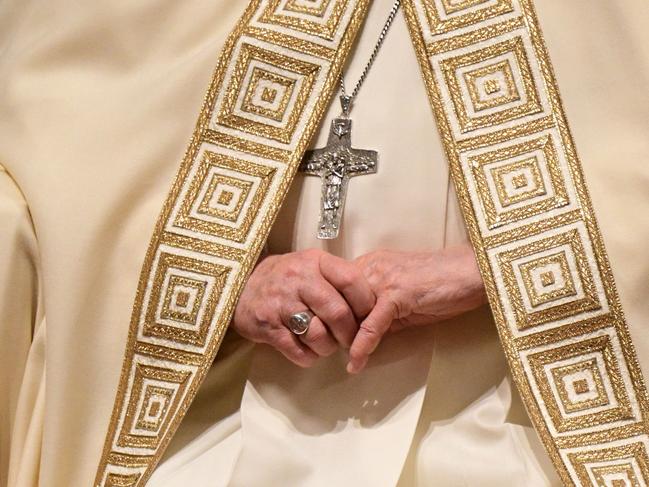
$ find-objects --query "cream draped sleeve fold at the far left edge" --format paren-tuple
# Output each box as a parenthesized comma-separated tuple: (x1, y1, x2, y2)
(0, 166, 45, 485)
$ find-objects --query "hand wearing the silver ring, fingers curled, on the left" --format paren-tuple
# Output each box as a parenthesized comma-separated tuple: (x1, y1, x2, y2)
(232, 249, 376, 367)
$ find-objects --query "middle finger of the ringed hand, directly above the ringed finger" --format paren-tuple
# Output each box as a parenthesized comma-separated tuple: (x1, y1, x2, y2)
(300, 276, 358, 348)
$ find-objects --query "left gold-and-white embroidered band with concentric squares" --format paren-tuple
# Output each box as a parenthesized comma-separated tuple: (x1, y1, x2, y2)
(95, 0, 369, 487)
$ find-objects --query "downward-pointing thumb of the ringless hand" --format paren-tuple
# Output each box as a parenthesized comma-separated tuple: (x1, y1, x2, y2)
(347, 299, 396, 374)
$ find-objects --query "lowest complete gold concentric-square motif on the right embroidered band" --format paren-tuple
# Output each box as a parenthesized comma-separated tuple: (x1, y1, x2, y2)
(527, 335, 635, 433)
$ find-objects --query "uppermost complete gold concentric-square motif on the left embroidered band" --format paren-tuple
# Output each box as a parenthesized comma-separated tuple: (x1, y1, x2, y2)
(215, 43, 321, 144)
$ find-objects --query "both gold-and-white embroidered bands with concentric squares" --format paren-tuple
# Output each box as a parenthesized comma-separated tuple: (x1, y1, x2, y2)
(95, 0, 649, 486)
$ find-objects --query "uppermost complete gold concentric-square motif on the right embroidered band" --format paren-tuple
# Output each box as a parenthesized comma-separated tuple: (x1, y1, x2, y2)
(440, 37, 543, 133)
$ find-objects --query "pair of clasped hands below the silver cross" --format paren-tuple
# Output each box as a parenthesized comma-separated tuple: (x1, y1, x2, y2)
(232, 245, 486, 373)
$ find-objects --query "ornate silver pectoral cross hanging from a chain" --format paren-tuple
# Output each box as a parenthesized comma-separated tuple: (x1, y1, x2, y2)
(299, 105, 379, 239)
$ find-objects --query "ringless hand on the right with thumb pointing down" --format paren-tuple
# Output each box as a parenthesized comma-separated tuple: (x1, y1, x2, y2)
(347, 245, 487, 373)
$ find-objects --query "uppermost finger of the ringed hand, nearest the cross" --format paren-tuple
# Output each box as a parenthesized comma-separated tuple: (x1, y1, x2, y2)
(320, 254, 376, 320)
